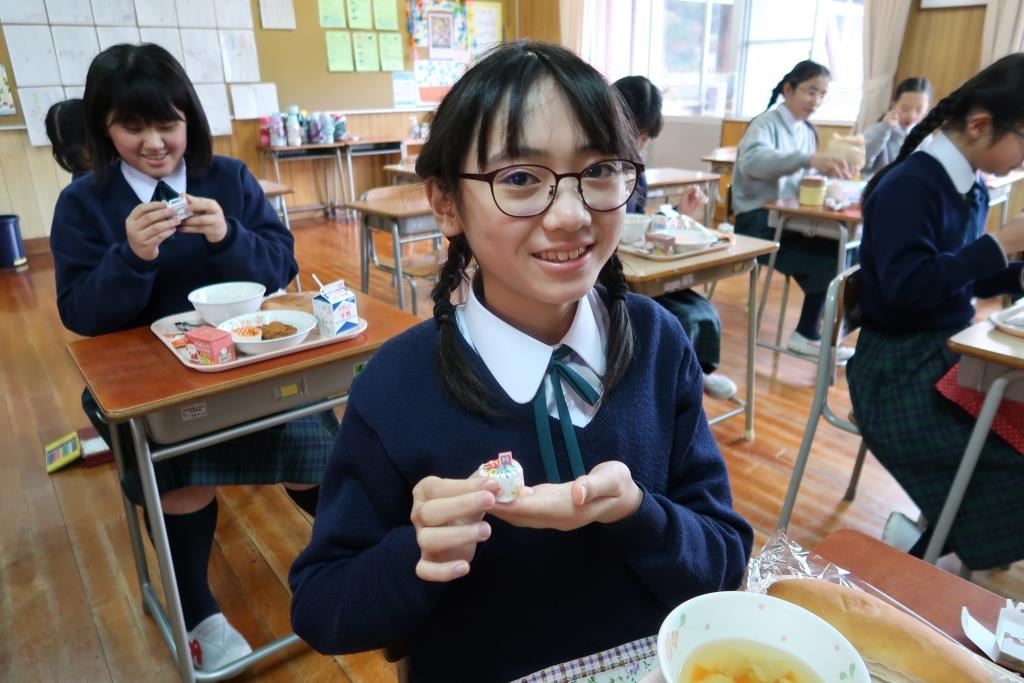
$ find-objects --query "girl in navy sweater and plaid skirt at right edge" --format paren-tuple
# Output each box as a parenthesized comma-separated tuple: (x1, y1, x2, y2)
(847, 53, 1024, 569)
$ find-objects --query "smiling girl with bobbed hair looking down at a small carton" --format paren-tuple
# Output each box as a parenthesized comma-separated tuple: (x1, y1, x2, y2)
(50, 45, 337, 671)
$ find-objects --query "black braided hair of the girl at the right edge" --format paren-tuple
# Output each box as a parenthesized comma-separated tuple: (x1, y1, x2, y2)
(860, 52, 1024, 206)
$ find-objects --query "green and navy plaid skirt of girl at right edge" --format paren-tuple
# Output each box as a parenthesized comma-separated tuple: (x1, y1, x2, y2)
(846, 329, 1024, 569)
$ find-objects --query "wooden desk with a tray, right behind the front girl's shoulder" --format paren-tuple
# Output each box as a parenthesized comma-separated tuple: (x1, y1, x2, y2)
(618, 234, 778, 441)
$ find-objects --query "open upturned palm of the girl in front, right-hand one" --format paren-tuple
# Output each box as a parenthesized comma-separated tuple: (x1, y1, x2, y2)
(489, 461, 643, 531)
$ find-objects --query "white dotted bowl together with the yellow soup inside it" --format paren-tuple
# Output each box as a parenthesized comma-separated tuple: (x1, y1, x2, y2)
(657, 591, 870, 683)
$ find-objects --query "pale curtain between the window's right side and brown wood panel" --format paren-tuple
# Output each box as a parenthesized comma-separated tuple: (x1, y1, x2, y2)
(856, 0, 911, 130)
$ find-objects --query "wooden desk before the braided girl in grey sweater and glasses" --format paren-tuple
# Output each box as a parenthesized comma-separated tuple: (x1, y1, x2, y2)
(758, 197, 863, 360)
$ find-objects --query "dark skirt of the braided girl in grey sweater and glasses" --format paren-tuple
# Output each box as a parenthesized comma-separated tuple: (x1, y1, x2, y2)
(736, 209, 857, 294)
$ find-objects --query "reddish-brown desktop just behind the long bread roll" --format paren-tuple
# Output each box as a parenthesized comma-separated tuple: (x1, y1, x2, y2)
(814, 529, 1007, 652)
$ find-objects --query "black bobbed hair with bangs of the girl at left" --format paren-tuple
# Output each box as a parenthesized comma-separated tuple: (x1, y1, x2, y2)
(85, 44, 213, 182)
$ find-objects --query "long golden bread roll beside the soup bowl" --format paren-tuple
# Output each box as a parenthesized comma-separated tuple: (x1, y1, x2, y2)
(768, 579, 991, 683)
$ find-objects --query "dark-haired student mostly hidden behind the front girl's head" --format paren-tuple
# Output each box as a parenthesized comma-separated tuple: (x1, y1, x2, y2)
(614, 76, 736, 398)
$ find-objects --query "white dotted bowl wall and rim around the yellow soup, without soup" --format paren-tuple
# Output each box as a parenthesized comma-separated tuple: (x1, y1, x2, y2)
(657, 591, 870, 683)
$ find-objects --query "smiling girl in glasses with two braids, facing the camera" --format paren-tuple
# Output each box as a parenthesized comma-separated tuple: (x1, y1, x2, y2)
(290, 42, 752, 682)
